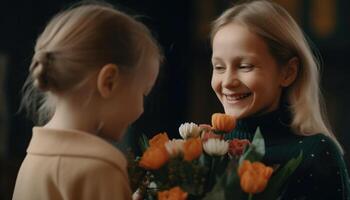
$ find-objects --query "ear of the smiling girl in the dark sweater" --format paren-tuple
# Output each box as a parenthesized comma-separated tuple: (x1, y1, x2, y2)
(281, 57, 299, 87)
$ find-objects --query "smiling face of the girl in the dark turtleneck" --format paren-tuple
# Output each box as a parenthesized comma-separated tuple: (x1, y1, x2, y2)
(211, 23, 283, 118)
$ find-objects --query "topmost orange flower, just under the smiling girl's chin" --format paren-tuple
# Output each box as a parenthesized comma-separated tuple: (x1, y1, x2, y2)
(211, 113, 236, 132)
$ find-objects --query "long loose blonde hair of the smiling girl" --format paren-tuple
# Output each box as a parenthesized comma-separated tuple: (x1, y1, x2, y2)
(211, 0, 342, 150)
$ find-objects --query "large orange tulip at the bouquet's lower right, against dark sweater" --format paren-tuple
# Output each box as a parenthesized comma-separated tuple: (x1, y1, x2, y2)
(238, 160, 273, 194)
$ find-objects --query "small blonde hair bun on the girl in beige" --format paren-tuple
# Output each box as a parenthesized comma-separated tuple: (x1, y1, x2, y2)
(29, 51, 52, 91)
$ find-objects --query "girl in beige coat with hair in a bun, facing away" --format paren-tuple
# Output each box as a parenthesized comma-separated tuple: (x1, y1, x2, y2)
(13, 3, 162, 200)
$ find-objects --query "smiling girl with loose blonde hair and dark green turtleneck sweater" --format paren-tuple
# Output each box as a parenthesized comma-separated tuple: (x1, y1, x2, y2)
(211, 0, 350, 200)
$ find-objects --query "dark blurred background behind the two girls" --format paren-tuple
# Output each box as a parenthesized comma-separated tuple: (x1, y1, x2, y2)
(0, 0, 350, 199)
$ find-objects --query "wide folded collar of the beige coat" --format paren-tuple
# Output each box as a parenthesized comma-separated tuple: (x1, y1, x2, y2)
(27, 128, 127, 172)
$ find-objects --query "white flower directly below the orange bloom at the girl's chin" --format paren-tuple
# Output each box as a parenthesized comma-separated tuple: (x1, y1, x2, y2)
(203, 138, 229, 156)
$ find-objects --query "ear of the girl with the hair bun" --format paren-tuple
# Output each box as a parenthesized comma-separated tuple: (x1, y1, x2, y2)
(97, 64, 120, 98)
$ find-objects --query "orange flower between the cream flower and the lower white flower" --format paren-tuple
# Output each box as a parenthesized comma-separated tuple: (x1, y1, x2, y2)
(184, 138, 203, 161)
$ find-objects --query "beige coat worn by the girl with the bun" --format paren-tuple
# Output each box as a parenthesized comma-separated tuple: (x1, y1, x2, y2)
(13, 127, 131, 200)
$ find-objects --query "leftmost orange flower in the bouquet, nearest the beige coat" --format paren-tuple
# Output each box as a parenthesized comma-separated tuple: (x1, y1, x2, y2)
(139, 146, 169, 169)
